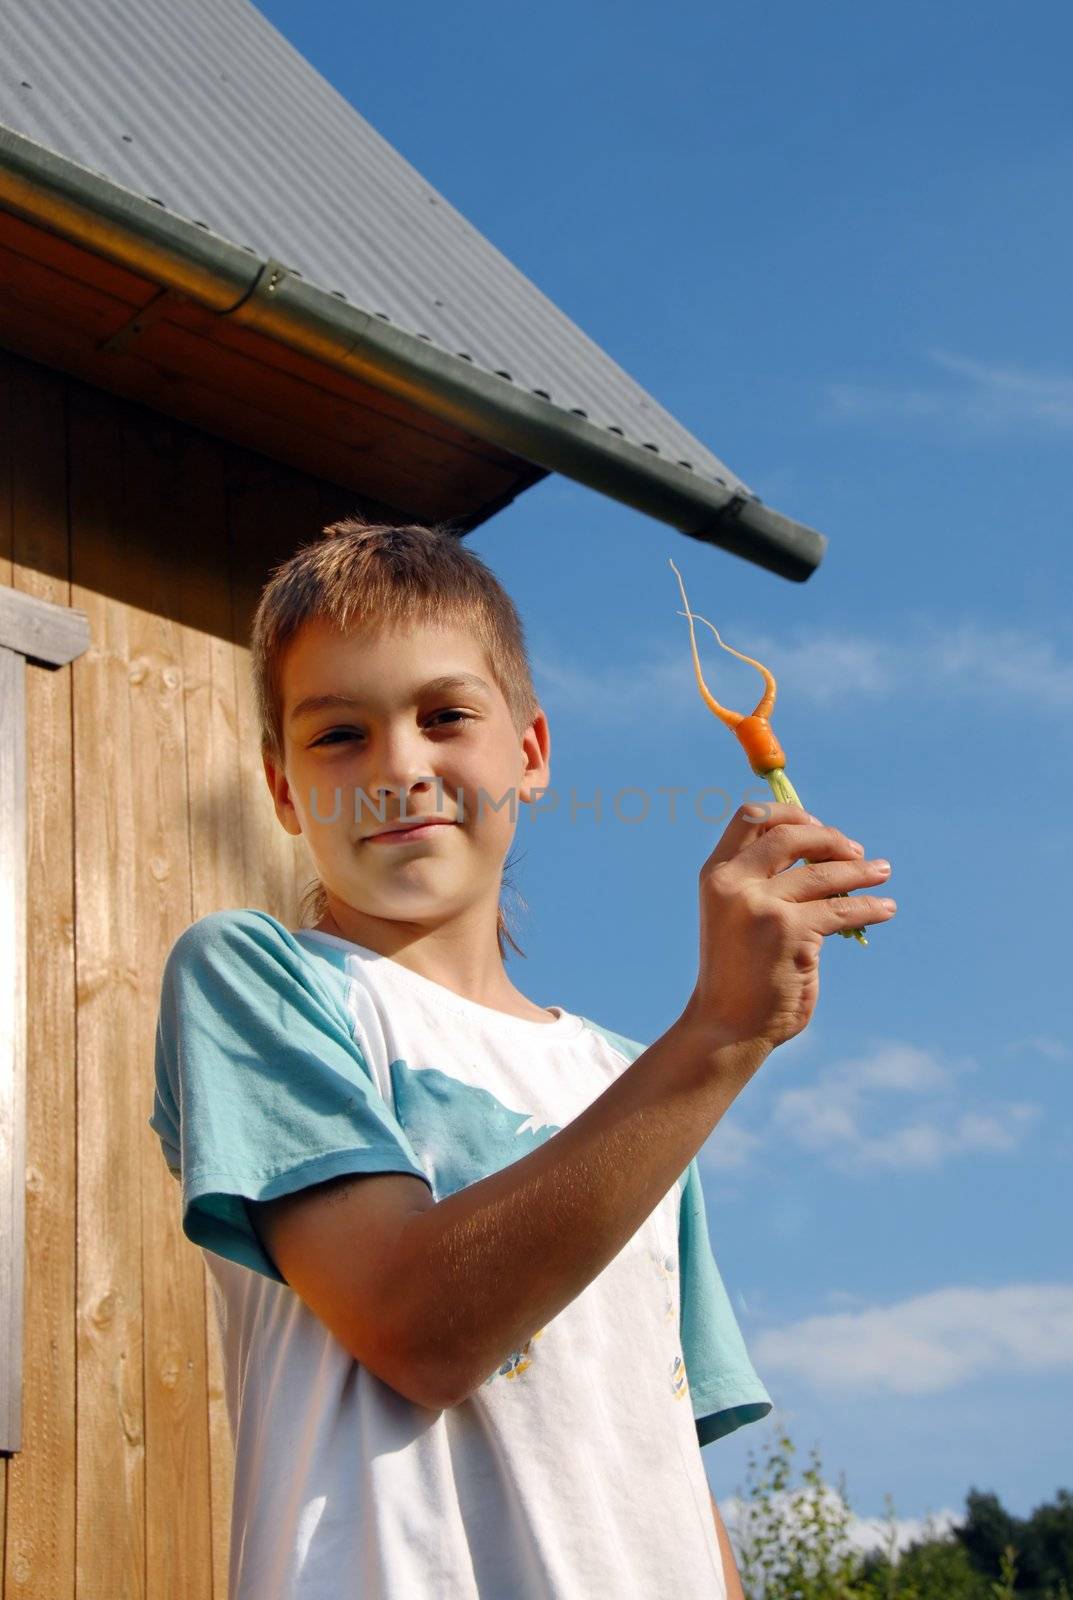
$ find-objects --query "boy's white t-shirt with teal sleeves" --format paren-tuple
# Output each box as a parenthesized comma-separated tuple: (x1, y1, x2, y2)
(149, 910, 771, 1600)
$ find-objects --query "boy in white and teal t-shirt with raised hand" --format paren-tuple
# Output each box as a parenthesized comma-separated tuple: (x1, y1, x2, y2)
(150, 518, 891, 1600)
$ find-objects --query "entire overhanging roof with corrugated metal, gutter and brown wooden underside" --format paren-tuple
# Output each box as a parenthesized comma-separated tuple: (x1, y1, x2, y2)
(0, 0, 827, 581)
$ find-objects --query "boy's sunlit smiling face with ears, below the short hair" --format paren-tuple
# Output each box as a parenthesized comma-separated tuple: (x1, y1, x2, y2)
(264, 621, 550, 925)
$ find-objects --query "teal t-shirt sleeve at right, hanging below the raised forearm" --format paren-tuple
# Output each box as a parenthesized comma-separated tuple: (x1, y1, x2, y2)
(678, 1158, 771, 1445)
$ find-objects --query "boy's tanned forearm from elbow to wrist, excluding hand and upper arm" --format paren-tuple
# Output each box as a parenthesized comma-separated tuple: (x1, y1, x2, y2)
(386, 1016, 769, 1406)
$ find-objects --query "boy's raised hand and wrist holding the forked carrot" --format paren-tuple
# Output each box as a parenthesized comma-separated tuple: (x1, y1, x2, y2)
(686, 802, 894, 1050)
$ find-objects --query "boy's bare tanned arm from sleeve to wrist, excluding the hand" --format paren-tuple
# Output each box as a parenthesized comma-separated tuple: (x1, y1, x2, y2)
(255, 1011, 771, 1410)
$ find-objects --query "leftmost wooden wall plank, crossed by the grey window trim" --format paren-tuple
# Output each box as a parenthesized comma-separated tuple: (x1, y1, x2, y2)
(5, 363, 77, 1600)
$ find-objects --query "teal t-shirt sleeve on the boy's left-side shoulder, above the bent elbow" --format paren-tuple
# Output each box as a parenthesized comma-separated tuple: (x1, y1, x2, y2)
(149, 910, 429, 1283)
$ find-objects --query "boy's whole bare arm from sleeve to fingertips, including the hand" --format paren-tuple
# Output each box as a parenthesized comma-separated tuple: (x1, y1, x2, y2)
(254, 805, 889, 1410)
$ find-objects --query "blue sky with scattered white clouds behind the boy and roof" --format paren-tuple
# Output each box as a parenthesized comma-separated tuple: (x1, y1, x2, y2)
(262, 0, 1073, 1548)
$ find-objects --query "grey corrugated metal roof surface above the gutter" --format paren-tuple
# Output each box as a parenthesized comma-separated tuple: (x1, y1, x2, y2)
(0, 0, 822, 565)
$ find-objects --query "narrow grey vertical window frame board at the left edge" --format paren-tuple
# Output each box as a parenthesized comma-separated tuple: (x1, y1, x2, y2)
(0, 646, 26, 1454)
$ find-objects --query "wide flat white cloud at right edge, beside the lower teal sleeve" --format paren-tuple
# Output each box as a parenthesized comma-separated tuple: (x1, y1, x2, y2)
(750, 1283, 1073, 1395)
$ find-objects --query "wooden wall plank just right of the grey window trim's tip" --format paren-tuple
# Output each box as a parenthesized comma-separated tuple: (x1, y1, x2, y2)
(69, 377, 150, 1600)
